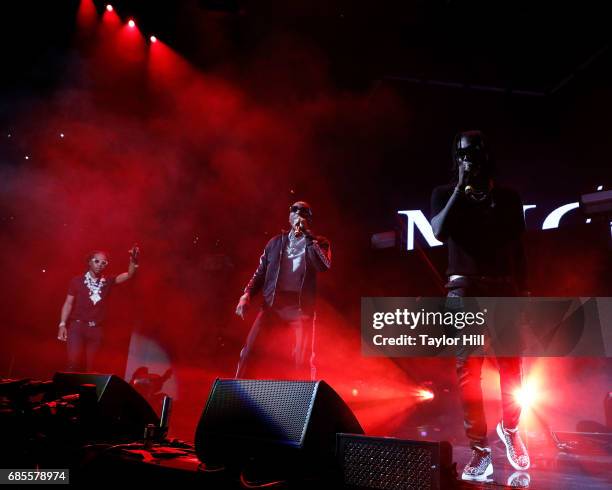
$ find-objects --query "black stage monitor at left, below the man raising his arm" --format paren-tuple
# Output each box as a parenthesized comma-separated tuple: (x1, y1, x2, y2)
(53, 372, 159, 440)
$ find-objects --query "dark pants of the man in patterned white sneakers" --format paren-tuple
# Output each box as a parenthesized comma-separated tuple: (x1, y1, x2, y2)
(447, 281, 522, 447)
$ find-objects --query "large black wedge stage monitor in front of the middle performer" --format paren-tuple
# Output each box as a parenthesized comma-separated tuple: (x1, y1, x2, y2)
(195, 379, 363, 466)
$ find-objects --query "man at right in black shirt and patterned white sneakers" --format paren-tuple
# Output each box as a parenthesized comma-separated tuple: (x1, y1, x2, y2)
(431, 131, 530, 481)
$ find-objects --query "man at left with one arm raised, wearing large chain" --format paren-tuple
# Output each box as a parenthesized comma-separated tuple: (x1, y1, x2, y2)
(57, 246, 140, 371)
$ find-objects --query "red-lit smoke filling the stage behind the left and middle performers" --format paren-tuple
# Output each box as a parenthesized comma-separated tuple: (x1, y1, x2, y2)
(0, 1, 603, 444)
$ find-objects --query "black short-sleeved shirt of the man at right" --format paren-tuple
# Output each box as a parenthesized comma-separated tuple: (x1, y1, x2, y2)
(431, 185, 525, 288)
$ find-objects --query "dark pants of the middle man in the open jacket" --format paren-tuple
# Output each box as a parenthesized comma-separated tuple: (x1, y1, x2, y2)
(236, 294, 316, 380)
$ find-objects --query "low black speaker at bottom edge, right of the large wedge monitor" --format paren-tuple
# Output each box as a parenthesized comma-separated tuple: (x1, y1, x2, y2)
(337, 434, 456, 490)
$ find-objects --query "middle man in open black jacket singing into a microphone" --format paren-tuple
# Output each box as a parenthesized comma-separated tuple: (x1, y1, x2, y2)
(236, 201, 331, 379)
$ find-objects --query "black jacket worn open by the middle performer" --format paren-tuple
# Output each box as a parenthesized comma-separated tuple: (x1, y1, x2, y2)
(244, 231, 331, 314)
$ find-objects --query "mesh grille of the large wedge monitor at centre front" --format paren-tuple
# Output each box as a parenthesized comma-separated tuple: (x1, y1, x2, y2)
(204, 379, 317, 446)
